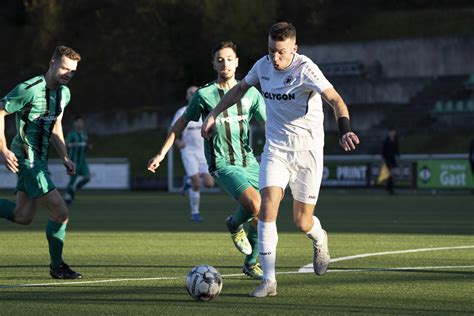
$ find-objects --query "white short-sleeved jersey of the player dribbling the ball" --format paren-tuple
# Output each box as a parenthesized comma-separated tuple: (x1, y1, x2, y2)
(245, 54, 332, 151)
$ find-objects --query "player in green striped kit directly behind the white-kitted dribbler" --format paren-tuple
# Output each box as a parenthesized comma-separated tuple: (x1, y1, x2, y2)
(148, 42, 265, 280)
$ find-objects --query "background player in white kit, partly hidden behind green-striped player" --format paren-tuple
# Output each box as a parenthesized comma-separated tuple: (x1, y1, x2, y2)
(171, 86, 214, 222)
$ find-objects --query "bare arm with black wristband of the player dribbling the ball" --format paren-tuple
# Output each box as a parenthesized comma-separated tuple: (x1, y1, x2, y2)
(321, 88, 360, 151)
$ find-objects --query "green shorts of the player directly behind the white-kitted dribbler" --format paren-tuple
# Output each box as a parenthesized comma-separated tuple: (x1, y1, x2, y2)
(212, 161, 259, 200)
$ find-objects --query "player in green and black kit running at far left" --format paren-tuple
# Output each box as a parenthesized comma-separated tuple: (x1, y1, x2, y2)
(0, 46, 82, 279)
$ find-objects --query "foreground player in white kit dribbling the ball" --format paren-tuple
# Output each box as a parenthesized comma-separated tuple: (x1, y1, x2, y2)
(202, 22, 359, 297)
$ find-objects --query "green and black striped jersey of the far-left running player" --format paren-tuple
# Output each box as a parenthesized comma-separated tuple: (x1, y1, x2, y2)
(2, 76, 71, 163)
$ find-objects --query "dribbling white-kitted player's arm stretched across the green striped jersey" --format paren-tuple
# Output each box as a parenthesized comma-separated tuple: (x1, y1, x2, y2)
(201, 80, 251, 138)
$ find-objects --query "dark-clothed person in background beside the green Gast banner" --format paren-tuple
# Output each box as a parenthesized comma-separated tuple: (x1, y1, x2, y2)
(382, 127, 400, 195)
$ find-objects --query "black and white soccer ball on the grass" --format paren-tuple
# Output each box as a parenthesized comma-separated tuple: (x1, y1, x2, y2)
(186, 264, 222, 301)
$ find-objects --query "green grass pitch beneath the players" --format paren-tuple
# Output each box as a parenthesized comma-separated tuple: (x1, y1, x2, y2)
(0, 190, 474, 315)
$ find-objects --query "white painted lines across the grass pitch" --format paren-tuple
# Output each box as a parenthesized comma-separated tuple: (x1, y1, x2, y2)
(0, 246, 474, 289)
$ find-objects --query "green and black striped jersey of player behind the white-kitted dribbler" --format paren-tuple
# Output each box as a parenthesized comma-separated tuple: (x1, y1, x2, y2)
(184, 82, 266, 172)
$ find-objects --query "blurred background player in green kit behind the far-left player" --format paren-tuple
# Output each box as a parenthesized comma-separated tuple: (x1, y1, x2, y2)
(64, 116, 92, 204)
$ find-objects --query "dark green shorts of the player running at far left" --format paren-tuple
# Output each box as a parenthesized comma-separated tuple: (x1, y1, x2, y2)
(16, 160, 56, 199)
